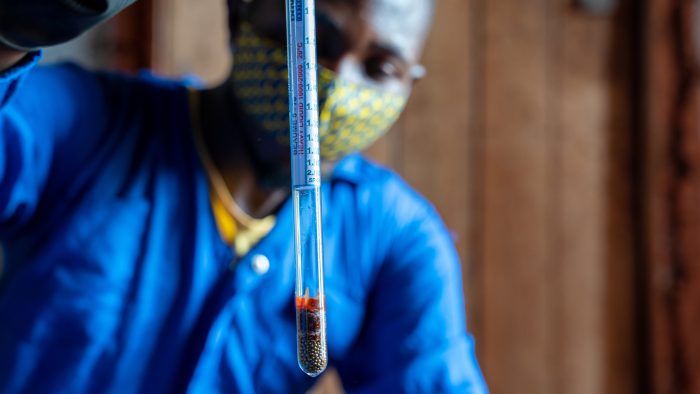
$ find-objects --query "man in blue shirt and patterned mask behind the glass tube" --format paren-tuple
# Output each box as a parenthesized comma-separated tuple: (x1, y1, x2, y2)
(0, 0, 487, 394)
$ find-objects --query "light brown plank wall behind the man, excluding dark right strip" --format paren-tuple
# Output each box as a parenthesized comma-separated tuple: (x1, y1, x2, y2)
(129, 0, 642, 394)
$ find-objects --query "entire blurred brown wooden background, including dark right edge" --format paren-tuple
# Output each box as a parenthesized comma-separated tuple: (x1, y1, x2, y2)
(37, 0, 700, 394)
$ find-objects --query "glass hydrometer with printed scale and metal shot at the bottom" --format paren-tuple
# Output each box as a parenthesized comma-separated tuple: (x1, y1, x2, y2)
(285, 0, 328, 376)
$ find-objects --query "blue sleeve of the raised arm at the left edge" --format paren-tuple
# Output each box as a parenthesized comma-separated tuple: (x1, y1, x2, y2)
(0, 51, 114, 240)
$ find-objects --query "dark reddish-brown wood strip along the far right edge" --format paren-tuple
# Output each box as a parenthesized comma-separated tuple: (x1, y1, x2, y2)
(644, 0, 700, 394)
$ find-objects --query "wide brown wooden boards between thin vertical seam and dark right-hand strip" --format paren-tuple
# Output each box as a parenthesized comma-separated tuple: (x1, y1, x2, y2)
(480, 1, 635, 393)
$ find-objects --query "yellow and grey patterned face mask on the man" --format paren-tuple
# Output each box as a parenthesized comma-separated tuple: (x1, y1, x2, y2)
(232, 24, 406, 160)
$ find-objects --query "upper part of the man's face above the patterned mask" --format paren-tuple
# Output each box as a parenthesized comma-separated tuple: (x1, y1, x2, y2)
(234, 0, 432, 95)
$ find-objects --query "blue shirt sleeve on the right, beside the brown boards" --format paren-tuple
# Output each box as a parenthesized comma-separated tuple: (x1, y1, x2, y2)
(338, 181, 487, 394)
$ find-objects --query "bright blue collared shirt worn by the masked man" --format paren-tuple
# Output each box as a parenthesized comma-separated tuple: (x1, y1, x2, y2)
(0, 53, 486, 394)
